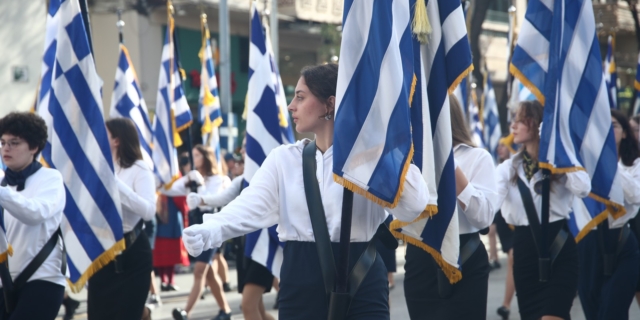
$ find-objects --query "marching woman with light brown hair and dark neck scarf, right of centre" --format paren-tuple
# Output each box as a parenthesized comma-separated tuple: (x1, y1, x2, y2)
(496, 101, 591, 320)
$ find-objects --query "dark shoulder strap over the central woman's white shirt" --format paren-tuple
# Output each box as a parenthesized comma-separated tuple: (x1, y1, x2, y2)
(302, 141, 336, 295)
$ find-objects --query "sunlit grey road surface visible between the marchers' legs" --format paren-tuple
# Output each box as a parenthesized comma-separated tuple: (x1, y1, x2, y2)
(57, 237, 640, 320)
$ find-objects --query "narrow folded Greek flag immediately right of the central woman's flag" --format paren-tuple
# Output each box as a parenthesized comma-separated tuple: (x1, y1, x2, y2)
(390, 0, 473, 283)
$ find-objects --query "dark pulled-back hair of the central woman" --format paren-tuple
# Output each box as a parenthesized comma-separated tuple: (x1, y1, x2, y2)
(300, 63, 338, 102)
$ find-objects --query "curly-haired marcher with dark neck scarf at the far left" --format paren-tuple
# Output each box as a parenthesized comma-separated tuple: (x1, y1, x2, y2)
(0, 112, 66, 320)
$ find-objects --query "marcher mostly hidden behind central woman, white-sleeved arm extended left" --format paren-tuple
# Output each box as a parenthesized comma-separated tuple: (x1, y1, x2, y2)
(187, 138, 274, 320)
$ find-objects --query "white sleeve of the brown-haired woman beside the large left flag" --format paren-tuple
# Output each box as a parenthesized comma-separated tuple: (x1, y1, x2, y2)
(116, 167, 156, 221)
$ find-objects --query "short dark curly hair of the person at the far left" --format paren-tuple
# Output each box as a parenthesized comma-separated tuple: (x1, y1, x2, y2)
(0, 112, 47, 160)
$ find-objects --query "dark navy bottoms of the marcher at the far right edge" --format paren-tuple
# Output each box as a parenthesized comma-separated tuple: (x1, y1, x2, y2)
(578, 229, 640, 320)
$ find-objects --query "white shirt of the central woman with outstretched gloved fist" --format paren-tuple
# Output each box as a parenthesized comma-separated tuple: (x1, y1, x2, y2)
(199, 140, 429, 247)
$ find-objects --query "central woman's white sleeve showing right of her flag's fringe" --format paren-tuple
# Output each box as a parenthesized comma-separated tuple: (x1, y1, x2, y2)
(387, 164, 429, 222)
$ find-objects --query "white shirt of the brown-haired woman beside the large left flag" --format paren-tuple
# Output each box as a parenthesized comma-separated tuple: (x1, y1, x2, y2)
(114, 160, 156, 233)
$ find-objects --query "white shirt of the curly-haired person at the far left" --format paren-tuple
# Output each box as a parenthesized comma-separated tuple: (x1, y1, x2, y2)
(0, 168, 66, 286)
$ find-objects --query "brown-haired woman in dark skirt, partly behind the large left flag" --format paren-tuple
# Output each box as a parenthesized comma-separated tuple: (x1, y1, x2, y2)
(87, 118, 156, 320)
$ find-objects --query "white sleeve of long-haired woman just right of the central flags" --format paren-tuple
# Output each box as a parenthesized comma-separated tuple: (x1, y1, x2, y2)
(458, 149, 499, 229)
